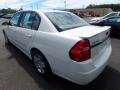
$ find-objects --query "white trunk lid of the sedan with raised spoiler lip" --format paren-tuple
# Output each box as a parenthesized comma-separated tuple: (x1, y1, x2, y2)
(61, 25, 110, 61)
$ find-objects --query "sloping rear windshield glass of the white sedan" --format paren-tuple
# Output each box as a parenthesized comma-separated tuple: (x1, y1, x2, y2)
(45, 12, 89, 32)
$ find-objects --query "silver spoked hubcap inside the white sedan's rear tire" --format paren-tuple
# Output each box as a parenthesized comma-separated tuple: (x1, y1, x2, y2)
(34, 54, 46, 74)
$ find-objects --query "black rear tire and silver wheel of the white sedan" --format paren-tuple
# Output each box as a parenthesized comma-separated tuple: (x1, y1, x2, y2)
(32, 50, 52, 77)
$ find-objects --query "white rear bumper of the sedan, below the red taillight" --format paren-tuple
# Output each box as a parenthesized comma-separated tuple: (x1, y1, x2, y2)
(64, 40, 112, 85)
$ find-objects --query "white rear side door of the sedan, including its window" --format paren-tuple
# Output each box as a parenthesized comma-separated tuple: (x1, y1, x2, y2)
(16, 12, 40, 53)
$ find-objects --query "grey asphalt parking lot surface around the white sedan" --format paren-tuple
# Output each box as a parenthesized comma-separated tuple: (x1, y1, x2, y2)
(0, 19, 120, 90)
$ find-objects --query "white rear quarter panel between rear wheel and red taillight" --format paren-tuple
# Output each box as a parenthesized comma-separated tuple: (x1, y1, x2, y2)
(32, 31, 80, 73)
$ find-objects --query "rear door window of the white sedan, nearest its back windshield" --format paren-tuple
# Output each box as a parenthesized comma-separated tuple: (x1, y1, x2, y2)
(19, 12, 40, 30)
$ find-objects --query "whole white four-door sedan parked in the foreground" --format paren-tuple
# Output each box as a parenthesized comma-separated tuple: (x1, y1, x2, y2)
(3, 10, 112, 85)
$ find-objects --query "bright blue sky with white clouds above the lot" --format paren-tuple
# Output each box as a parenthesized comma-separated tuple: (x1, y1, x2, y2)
(0, 0, 120, 9)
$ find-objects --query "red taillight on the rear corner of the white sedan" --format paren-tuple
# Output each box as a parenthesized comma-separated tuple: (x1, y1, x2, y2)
(69, 39, 91, 62)
